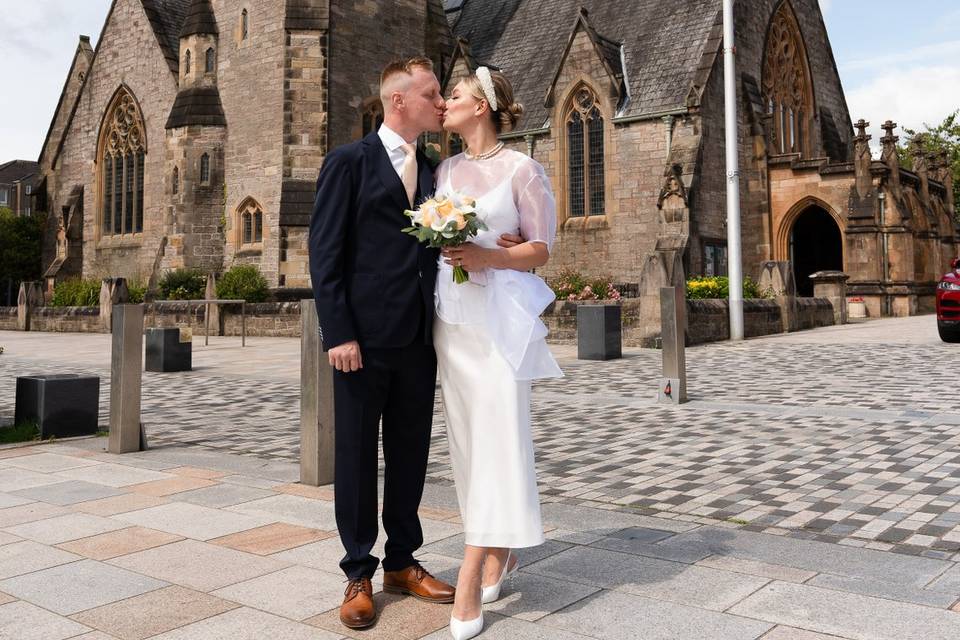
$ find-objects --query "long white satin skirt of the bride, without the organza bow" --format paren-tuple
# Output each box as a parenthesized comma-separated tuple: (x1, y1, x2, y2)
(433, 318, 544, 549)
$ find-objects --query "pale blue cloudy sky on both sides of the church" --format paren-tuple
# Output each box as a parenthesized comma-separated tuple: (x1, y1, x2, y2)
(0, 0, 960, 162)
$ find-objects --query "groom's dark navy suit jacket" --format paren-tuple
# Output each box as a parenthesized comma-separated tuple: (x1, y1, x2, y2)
(310, 132, 439, 353)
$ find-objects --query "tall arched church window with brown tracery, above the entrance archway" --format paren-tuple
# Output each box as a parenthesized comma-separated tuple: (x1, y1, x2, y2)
(763, 1, 813, 154)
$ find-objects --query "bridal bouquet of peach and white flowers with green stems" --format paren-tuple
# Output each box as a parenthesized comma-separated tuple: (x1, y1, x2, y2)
(403, 192, 487, 284)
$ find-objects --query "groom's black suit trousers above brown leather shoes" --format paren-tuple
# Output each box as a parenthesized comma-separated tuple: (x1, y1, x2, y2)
(333, 340, 437, 578)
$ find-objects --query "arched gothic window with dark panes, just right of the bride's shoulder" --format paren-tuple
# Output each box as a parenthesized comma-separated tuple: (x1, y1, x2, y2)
(566, 87, 606, 217)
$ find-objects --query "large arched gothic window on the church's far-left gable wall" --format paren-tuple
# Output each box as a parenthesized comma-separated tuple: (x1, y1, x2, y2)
(97, 87, 147, 236)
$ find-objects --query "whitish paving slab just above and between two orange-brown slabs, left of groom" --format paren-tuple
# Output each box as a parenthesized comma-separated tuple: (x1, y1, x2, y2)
(113, 502, 276, 540)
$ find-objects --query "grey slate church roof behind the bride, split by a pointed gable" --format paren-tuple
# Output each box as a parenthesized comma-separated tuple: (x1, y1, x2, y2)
(448, 0, 721, 131)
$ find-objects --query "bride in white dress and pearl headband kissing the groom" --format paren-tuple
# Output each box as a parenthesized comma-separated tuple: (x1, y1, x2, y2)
(434, 67, 563, 640)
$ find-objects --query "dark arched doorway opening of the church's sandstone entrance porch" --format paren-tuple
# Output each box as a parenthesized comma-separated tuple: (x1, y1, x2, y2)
(790, 206, 843, 296)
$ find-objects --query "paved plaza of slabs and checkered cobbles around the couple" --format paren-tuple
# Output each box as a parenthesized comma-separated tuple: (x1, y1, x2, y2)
(0, 316, 960, 640)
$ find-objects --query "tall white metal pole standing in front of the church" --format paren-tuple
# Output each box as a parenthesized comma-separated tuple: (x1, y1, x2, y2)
(723, 0, 743, 340)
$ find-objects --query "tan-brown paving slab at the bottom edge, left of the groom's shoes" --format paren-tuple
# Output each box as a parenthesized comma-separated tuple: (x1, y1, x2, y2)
(72, 586, 240, 640)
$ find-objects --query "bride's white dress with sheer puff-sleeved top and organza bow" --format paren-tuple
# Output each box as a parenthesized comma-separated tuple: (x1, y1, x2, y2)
(433, 149, 563, 549)
